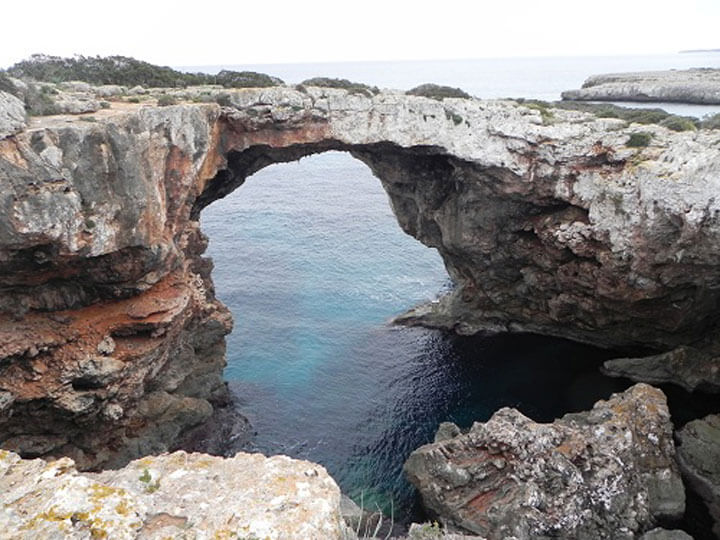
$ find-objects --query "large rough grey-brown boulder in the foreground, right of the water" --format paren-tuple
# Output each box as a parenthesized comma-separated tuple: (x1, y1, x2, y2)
(405, 384, 685, 540)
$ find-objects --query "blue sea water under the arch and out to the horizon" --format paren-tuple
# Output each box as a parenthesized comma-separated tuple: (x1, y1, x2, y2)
(200, 53, 720, 520)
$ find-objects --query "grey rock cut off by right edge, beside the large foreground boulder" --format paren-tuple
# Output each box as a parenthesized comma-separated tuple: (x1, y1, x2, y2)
(676, 414, 720, 536)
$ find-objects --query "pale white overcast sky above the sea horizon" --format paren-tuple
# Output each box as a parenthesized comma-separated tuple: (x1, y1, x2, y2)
(0, 0, 720, 67)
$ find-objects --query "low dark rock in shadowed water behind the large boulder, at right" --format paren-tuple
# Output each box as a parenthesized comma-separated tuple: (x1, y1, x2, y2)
(602, 347, 720, 394)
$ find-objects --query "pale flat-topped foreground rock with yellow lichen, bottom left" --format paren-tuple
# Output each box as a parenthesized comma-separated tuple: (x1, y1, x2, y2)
(0, 450, 351, 540)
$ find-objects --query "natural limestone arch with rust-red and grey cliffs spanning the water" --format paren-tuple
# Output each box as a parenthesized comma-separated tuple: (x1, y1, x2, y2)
(0, 83, 720, 468)
